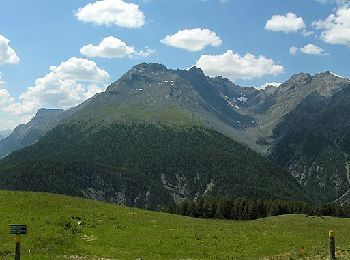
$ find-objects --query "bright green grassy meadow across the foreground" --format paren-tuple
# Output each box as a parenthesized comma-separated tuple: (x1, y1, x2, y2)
(0, 191, 350, 260)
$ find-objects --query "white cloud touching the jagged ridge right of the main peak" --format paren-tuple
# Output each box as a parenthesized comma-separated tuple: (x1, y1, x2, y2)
(196, 50, 284, 81)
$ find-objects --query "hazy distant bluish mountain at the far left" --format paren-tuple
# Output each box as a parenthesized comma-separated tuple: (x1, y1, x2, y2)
(0, 109, 67, 158)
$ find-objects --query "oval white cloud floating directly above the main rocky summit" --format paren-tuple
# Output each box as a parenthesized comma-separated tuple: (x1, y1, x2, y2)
(160, 28, 222, 51)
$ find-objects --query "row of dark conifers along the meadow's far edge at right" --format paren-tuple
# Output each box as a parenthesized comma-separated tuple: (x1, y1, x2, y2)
(164, 197, 350, 220)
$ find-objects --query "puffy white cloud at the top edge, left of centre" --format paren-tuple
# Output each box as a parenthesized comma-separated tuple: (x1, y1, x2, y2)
(75, 0, 145, 28)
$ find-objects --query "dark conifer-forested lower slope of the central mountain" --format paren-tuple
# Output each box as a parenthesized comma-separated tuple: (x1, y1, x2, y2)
(0, 122, 306, 209)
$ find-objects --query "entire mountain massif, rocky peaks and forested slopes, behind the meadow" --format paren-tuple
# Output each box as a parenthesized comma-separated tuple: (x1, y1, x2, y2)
(0, 63, 350, 209)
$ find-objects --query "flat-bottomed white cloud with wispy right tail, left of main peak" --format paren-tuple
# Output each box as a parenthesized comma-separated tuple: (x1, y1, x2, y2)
(80, 36, 154, 58)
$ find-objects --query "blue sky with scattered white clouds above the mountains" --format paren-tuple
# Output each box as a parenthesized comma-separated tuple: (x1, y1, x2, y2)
(0, 0, 350, 131)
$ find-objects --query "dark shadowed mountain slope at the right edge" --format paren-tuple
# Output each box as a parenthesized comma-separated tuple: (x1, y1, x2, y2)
(270, 87, 350, 203)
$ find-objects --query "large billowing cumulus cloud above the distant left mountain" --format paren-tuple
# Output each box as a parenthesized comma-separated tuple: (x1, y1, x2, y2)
(3, 57, 109, 116)
